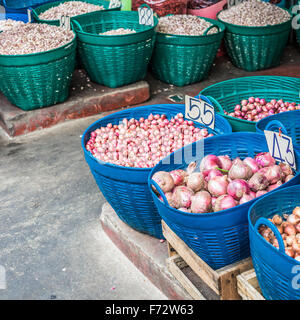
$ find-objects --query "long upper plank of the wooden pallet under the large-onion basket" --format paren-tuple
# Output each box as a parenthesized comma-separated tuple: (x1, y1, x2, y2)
(162, 221, 219, 294)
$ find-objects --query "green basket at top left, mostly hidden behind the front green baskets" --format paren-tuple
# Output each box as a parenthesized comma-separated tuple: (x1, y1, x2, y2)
(32, 0, 121, 26)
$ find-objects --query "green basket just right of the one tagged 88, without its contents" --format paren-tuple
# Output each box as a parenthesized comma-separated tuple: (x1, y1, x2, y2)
(151, 17, 225, 87)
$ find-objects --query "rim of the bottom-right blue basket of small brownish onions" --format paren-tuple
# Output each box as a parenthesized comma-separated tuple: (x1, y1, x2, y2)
(248, 185, 300, 265)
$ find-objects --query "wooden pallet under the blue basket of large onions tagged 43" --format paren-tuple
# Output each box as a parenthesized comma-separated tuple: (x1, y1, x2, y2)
(162, 221, 253, 300)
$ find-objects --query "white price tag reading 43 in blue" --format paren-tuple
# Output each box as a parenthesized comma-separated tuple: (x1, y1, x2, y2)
(264, 130, 296, 170)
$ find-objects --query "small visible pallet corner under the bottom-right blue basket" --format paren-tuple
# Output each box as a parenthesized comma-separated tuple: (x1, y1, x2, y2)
(237, 269, 265, 300)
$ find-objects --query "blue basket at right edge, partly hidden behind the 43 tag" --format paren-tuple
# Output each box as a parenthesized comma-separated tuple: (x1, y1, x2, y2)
(256, 110, 300, 152)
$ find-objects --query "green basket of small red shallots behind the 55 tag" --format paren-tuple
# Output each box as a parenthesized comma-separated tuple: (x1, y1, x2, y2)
(200, 76, 300, 132)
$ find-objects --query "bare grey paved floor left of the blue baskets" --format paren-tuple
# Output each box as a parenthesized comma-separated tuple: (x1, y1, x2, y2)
(0, 116, 166, 299)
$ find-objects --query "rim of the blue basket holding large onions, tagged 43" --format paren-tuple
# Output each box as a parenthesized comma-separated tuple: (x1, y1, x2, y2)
(148, 132, 300, 219)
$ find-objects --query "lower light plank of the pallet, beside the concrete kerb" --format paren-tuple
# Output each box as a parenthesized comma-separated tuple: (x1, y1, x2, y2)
(166, 255, 206, 300)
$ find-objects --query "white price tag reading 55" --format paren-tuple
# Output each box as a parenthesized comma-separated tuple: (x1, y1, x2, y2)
(185, 96, 215, 129)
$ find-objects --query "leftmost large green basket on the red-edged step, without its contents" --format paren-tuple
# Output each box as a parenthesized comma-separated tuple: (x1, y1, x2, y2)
(0, 37, 76, 111)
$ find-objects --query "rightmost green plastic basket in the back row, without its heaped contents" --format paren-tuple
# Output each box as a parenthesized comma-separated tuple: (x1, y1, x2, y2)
(217, 9, 292, 71)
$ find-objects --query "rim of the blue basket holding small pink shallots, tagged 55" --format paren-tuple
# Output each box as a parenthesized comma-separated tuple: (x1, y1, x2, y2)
(81, 103, 232, 172)
